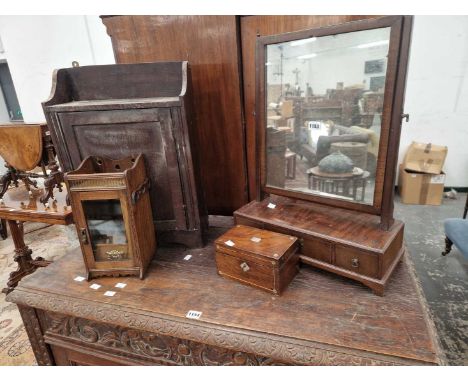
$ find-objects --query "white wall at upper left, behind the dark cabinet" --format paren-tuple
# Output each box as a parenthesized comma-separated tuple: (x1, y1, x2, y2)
(0, 16, 115, 123)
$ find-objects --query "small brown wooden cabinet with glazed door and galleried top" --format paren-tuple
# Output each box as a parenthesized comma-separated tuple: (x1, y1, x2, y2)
(65, 154, 156, 280)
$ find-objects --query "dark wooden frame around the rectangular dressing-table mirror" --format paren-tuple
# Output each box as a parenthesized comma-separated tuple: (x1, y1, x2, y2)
(255, 16, 413, 230)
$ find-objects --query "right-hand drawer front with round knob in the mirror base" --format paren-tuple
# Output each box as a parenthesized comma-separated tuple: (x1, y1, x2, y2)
(335, 245, 379, 277)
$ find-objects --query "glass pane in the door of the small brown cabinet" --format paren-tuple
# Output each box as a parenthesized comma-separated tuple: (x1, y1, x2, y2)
(82, 199, 128, 261)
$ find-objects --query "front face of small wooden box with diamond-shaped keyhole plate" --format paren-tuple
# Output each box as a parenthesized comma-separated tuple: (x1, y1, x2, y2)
(216, 252, 279, 293)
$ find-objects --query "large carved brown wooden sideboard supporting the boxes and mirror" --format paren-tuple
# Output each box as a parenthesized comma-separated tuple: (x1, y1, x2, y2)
(7, 222, 441, 365)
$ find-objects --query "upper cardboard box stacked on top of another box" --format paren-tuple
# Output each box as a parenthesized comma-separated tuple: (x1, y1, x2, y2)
(403, 142, 448, 175)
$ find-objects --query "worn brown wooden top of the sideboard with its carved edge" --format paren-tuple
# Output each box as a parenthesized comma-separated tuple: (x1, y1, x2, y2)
(8, 219, 439, 364)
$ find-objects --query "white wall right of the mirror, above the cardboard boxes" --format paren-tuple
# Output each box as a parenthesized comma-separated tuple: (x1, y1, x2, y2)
(400, 16, 468, 187)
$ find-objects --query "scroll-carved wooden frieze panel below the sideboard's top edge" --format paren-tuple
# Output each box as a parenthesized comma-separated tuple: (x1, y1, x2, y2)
(45, 313, 284, 366)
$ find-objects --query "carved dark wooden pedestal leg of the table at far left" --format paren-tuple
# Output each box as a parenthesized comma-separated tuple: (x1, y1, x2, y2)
(2, 220, 50, 294)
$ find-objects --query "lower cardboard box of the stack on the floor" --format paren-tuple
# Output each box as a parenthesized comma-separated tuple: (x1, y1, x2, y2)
(398, 164, 445, 206)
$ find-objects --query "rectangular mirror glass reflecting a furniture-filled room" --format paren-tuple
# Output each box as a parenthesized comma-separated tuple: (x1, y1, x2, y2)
(265, 28, 390, 205)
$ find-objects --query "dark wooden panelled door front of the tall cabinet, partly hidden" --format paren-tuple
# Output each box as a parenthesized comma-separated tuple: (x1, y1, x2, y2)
(57, 108, 188, 230)
